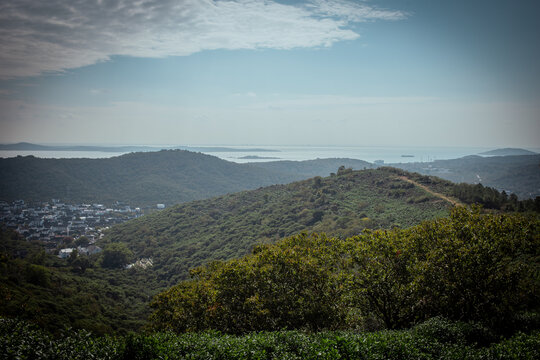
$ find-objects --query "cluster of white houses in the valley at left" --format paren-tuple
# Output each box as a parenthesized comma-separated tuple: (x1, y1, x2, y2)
(0, 199, 142, 258)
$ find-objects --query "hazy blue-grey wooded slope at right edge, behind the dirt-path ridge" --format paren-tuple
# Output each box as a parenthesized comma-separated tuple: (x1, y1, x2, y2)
(390, 155, 540, 199)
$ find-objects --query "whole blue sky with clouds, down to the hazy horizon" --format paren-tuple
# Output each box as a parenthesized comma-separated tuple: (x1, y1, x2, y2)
(0, 0, 540, 148)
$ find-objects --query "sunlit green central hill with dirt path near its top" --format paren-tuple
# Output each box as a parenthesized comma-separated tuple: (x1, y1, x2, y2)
(101, 168, 453, 286)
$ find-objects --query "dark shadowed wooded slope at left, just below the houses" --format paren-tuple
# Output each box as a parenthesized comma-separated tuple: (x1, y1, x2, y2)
(0, 229, 156, 334)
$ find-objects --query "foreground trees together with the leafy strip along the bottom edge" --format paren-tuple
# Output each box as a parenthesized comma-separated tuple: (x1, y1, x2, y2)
(0, 207, 540, 359)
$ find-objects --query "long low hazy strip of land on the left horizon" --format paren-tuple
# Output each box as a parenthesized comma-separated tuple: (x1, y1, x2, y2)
(0, 142, 279, 153)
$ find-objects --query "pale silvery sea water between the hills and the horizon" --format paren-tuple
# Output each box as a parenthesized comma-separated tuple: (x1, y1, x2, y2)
(0, 145, 493, 163)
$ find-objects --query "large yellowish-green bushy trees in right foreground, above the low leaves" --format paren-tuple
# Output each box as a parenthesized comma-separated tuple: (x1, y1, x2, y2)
(152, 207, 540, 333)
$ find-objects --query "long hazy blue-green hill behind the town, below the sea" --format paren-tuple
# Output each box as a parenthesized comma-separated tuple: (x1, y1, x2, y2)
(0, 150, 370, 206)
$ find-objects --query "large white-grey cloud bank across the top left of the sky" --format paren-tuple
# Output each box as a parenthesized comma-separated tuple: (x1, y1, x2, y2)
(0, 0, 406, 78)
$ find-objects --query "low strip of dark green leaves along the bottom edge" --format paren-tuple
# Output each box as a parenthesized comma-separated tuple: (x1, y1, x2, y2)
(0, 318, 540, 360)
